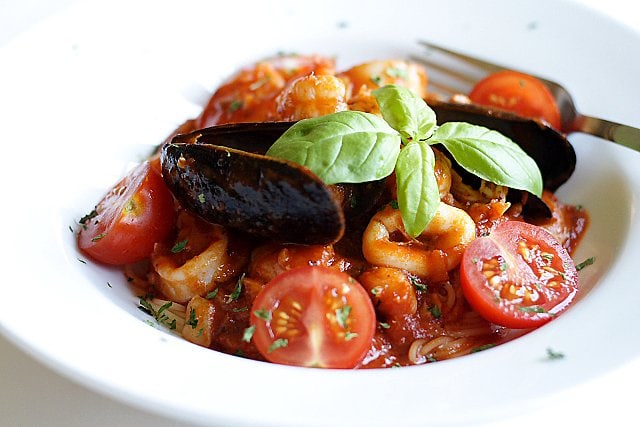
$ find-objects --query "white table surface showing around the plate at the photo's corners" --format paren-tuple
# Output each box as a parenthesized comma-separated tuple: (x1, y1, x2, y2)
(0, 0, 640, 427)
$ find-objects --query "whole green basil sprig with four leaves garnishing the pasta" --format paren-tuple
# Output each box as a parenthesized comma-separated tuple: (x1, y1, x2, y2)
(267, 85, 543, 237)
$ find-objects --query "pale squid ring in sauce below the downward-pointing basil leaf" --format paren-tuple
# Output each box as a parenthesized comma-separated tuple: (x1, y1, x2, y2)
(362, 202, 476, 282)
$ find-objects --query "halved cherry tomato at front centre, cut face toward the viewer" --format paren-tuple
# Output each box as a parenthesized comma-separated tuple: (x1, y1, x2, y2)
(251, 266, 376, 368)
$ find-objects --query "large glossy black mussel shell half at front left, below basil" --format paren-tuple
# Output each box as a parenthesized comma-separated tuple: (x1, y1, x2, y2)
(161, 143, 345, 244)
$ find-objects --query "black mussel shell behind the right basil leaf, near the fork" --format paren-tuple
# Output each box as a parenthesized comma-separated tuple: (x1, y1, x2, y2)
(429, 101, 576, 191)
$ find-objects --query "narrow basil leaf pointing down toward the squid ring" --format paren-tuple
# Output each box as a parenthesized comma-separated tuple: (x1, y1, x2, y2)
(396, 141, 440, 237)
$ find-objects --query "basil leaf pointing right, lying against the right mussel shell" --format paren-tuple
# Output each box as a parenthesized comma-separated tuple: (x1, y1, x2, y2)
(429, 122, 543, 197)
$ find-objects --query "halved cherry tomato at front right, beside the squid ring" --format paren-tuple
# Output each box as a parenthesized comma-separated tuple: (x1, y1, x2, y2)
(460, 221, 578, 328)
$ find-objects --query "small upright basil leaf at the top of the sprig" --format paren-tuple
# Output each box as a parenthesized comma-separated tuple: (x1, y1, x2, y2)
(371, 85, 436, 143)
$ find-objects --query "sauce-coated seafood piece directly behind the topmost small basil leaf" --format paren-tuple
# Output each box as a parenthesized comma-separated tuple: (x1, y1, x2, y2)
(338, 60, 427, 114)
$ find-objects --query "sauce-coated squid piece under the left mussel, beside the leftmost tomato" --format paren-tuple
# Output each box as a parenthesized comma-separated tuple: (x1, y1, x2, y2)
(149, 211, 248, 303)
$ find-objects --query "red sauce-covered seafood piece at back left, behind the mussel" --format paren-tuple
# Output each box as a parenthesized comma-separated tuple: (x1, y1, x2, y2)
(196, 55, 335, 128)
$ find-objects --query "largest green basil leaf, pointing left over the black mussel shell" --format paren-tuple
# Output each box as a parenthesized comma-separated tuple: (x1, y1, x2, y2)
(267, 111, 400, 184)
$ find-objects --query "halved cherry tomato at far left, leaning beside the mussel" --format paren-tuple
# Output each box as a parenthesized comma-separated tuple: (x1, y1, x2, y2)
(78, 161, 176, 265)
